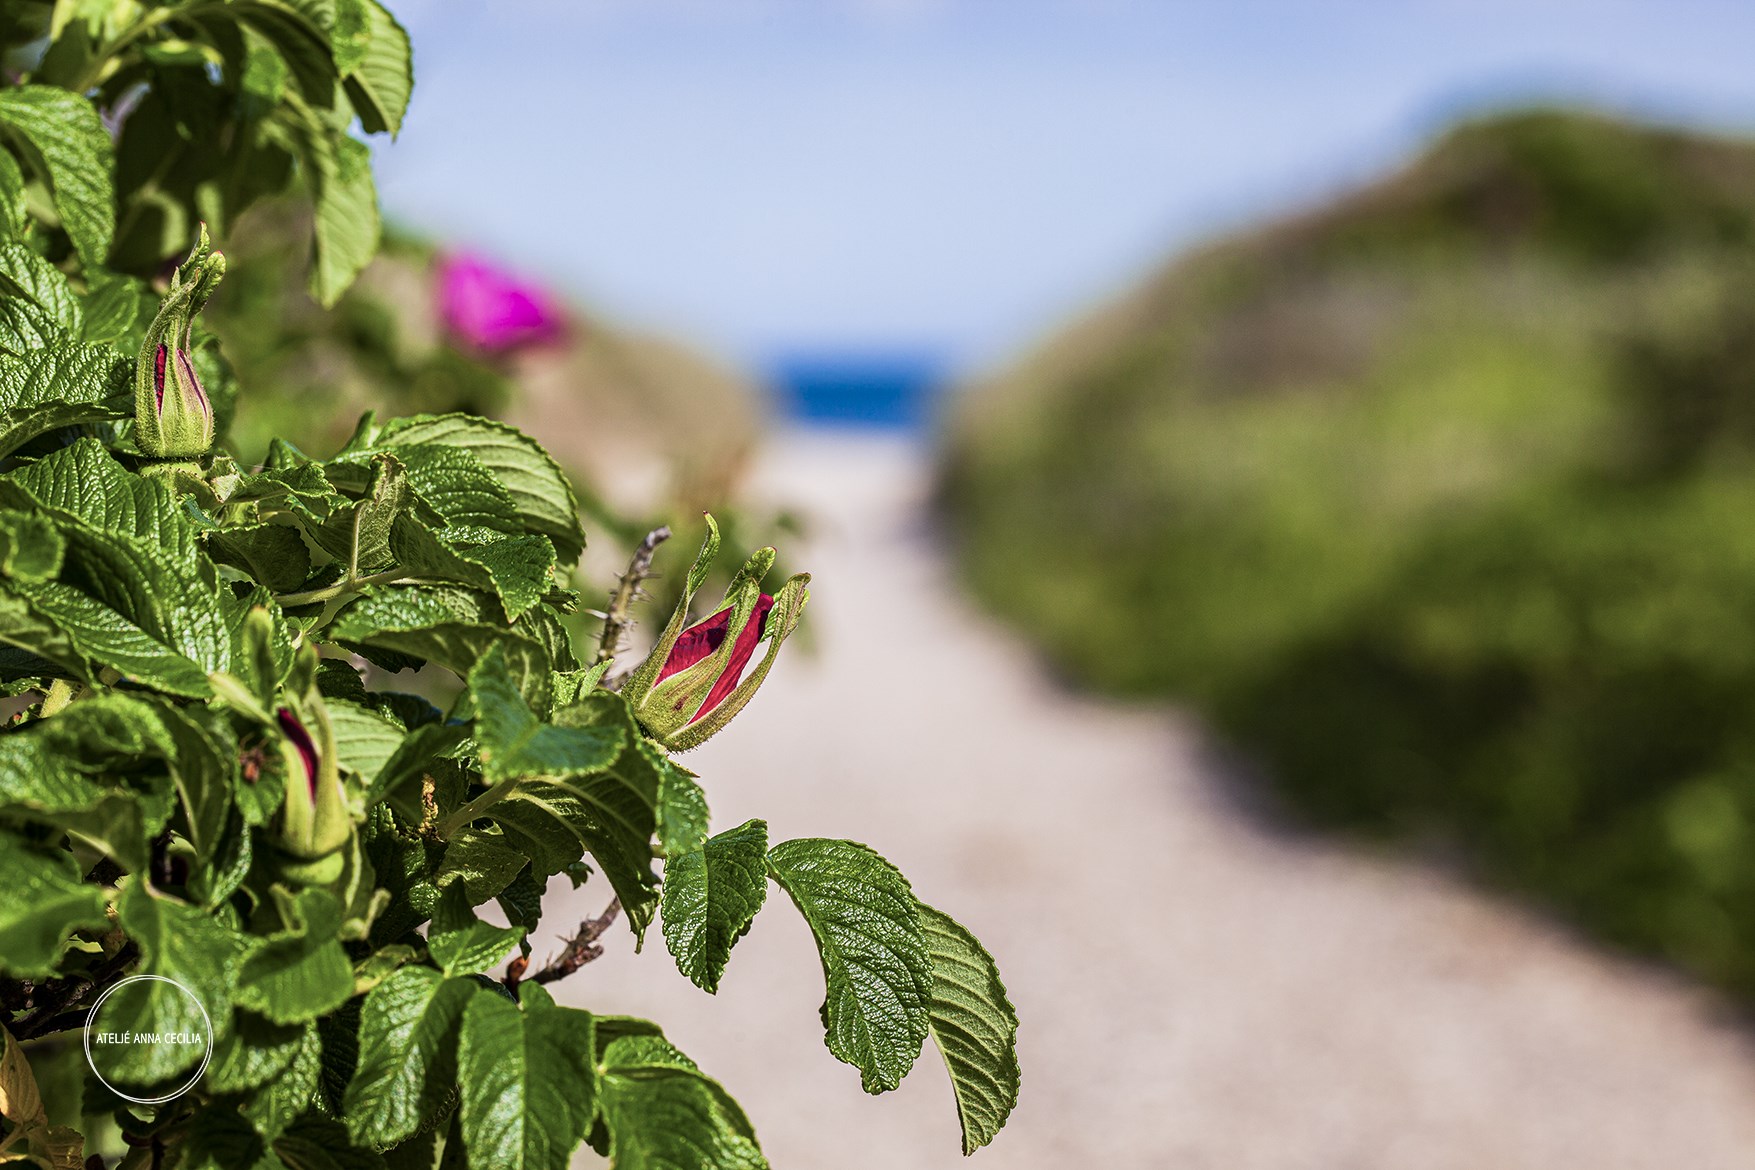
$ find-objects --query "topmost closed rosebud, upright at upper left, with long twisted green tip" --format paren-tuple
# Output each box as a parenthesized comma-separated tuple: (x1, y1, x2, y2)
(133, 225, 225, 460)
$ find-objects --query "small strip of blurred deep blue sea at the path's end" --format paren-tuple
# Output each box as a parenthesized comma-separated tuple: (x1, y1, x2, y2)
(769, 353, 948, 432)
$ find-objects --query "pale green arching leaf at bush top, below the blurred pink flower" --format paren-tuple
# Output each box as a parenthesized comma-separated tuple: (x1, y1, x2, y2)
(377, 414, 584, 565)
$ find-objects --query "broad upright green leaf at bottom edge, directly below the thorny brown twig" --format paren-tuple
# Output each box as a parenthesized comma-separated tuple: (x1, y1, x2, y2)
(458, 982, 597, 1170)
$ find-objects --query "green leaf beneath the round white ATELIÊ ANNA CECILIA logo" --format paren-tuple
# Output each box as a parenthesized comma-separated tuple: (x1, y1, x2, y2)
(114, 879, 246, 1084)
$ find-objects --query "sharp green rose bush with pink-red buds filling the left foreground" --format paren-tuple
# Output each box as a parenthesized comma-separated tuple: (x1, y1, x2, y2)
(0, 0, 1018, 1170)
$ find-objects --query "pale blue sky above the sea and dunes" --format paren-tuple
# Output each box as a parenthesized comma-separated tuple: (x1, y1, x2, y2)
(379, 0, 1755, 365)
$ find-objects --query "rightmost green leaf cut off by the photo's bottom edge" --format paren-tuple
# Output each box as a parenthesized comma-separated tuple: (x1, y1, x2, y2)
(598, 1035, 767, 1170)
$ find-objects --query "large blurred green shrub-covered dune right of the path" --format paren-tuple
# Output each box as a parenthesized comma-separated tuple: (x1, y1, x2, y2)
(941, 111, 1755, 993)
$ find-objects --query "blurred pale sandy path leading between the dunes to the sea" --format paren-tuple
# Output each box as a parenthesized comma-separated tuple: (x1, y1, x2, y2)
(554, 435, 1755, 1170)
